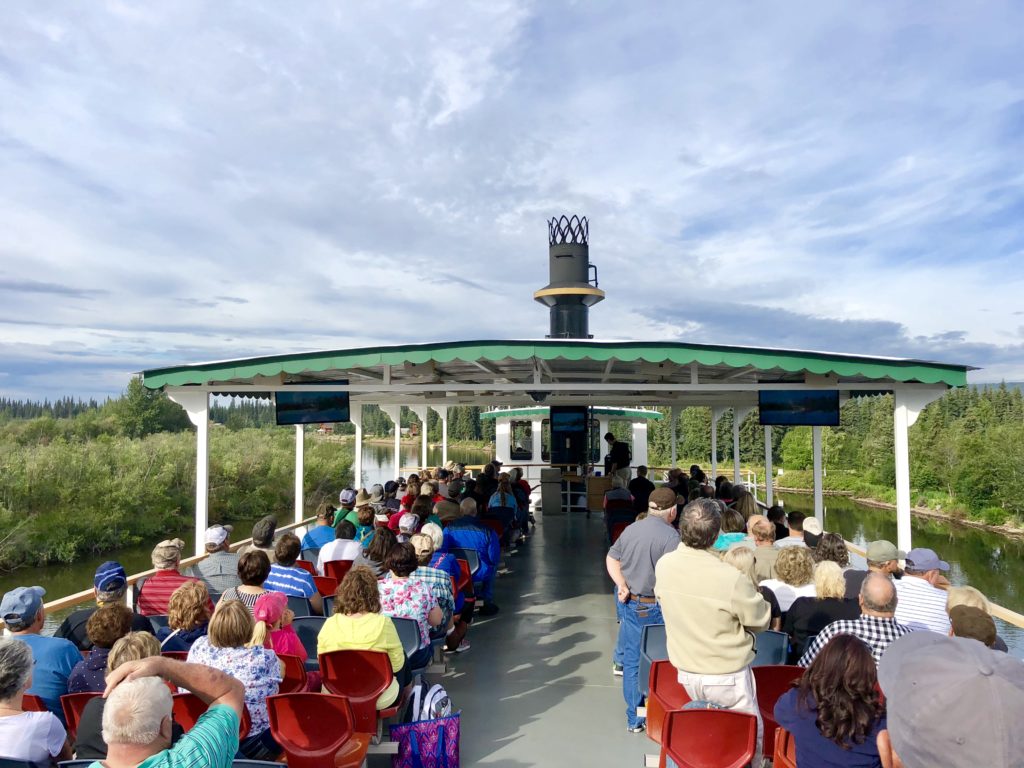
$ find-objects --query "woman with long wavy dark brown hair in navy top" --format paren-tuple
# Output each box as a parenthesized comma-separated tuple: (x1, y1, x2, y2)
(775, 635, 893, 768)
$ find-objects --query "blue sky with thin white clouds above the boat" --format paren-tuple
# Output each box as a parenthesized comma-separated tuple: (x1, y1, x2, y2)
(0, 0, 1024, 399)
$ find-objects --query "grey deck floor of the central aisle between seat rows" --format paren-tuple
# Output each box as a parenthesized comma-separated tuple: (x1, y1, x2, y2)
(443, 514, 656, 768)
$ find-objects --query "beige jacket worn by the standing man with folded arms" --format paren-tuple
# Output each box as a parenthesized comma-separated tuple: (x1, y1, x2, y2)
(654, 545, 771, 675)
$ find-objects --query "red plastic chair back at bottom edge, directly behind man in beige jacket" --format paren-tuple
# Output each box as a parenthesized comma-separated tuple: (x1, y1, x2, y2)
(660, 710, 758, 768)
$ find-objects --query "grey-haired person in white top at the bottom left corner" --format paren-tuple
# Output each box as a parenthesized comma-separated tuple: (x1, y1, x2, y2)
(0, 638, 72, 765)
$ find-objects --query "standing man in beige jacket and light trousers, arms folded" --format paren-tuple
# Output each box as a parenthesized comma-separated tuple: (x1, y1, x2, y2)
(654, 499, 771, 766)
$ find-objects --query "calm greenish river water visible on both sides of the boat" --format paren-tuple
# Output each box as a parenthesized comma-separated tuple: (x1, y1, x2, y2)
(0, 443, 1024, 657)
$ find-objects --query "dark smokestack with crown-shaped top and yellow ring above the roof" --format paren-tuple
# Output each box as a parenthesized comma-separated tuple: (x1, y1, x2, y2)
(534, 216, 604, 339)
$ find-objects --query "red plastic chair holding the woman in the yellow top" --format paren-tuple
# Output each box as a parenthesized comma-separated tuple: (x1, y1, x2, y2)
(319, 650, 401, 733)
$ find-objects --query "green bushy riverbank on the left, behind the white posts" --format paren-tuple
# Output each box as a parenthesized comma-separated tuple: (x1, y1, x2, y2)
(0, 427, 352, 569)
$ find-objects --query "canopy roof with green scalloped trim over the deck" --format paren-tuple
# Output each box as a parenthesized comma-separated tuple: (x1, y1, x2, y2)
(142, 339, 973, 389)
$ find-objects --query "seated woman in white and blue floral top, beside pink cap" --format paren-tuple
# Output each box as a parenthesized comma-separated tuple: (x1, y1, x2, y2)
(188, 602, 284, 760)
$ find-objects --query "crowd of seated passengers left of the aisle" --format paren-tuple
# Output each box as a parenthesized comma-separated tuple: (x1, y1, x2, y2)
(0, 461, 530, 768)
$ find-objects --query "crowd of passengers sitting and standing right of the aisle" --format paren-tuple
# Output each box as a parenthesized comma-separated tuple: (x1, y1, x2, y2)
(604, 465, 1024, 768)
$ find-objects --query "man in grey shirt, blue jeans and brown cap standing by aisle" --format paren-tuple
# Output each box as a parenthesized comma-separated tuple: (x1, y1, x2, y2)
(604, 488, 679, 733)
